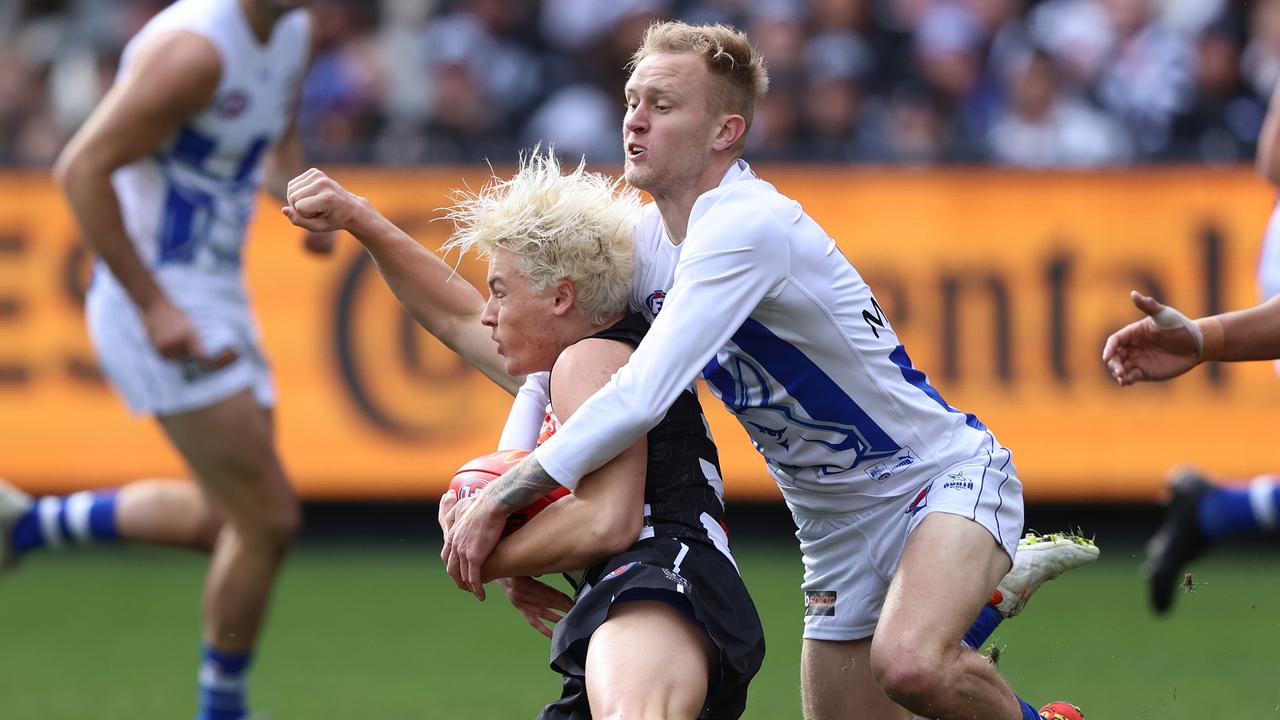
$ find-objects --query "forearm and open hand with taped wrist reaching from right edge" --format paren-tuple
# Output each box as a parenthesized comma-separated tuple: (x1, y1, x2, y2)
(1102, 292, 1280, 386)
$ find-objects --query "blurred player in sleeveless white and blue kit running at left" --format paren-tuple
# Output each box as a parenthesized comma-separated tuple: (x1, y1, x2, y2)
(0, 0, 325, 720)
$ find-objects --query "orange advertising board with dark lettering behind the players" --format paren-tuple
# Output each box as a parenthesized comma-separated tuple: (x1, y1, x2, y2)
(0, 168, 1280, 500)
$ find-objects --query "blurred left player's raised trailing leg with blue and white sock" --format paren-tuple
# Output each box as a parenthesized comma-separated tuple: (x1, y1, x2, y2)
(0, 479, 221, 568)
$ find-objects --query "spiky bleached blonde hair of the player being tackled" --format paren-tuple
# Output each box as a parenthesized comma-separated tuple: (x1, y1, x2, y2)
(442, 147, 640, 324)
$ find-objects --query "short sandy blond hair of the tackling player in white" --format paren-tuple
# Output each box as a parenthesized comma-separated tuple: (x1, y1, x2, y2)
(630, 20, 769, 155)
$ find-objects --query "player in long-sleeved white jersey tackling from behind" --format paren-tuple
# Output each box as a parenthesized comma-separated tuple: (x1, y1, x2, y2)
(427, 23, 1093, 720)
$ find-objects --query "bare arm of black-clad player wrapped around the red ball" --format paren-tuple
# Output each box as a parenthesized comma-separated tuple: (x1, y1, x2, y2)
(481, 340, 648, 582)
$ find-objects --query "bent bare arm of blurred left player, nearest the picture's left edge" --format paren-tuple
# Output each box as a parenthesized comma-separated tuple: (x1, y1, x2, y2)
(54, 31, 223, 359)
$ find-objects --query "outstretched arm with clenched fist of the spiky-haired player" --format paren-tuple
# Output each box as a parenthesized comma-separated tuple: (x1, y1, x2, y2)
(282, 168, 524, 395)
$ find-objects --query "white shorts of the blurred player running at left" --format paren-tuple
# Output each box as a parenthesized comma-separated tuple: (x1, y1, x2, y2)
(84, 268, 275, 416)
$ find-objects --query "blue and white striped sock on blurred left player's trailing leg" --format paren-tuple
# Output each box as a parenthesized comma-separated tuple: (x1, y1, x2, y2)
(13, 489, 120, 552)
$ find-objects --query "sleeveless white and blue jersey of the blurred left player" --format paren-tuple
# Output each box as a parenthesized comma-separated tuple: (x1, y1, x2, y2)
(104, 0, 311, 275)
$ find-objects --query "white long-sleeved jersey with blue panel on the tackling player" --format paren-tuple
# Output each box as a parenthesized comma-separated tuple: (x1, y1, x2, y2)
(536, 160, 1012, 512)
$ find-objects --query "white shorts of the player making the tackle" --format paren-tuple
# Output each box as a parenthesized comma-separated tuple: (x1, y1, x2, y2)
(795, 447, 1023, 641)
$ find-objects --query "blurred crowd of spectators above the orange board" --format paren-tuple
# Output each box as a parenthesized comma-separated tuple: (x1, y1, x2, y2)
(0, 0, 1280, 167)
